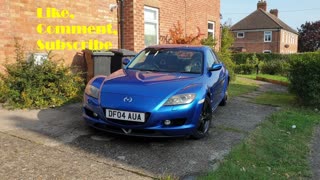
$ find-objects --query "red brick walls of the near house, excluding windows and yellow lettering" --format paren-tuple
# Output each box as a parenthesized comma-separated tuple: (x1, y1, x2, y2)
(0, 0, 220, 65)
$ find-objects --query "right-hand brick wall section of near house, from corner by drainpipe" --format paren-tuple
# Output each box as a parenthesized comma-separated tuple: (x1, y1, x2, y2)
(124, 0, 220, 51)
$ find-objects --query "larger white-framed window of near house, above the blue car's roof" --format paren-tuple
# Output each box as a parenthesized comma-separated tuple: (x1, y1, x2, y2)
(144, 6, 159, 46)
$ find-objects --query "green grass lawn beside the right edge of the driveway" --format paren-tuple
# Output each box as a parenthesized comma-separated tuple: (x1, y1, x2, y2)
(199, 79, 320, 180)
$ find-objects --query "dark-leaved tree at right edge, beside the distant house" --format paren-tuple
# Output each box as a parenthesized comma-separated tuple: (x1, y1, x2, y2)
(298, 21, 320, 52)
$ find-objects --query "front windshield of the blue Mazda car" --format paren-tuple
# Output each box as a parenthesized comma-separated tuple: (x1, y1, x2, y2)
(128, 48, 203, 74)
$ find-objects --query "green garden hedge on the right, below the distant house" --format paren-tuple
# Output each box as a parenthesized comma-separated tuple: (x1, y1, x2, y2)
(232, 51, 320, 106)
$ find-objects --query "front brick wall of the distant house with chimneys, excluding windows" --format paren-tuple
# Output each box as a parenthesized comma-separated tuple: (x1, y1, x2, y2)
(233, 31, 280, 53)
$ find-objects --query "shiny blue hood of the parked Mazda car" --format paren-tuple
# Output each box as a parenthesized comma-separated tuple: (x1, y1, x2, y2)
(101, 69, 201, 98)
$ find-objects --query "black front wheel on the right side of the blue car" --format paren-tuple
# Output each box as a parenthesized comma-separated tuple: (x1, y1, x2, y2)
(191, 97, 212, 139)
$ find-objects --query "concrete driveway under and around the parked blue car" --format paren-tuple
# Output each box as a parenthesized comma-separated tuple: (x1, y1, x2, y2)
(0, 81, 285, 179)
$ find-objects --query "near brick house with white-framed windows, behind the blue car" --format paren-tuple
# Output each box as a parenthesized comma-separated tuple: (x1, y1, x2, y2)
(0, 0, 220, 66)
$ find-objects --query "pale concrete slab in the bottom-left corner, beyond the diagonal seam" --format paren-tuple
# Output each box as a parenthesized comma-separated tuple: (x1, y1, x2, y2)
(0, 132, 151, 180)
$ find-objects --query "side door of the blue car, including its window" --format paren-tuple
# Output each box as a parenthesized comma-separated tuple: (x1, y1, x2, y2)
(206, 49, 226, 109)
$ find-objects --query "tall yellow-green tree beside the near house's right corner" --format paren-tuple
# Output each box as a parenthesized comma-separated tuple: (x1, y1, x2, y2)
(218, 25, 236, 79)
